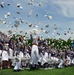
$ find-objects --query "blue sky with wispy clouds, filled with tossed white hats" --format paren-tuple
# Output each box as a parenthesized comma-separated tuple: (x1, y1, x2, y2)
(0, 0, 74, 40)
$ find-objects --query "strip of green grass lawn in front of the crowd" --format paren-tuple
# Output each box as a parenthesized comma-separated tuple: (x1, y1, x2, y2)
(0, 67, 74, 75)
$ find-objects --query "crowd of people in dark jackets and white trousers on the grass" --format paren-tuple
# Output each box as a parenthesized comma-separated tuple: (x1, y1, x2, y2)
(0, 34, 74, 71)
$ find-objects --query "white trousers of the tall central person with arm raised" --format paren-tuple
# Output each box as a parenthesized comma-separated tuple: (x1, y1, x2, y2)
(30, 45, 39, 65)
